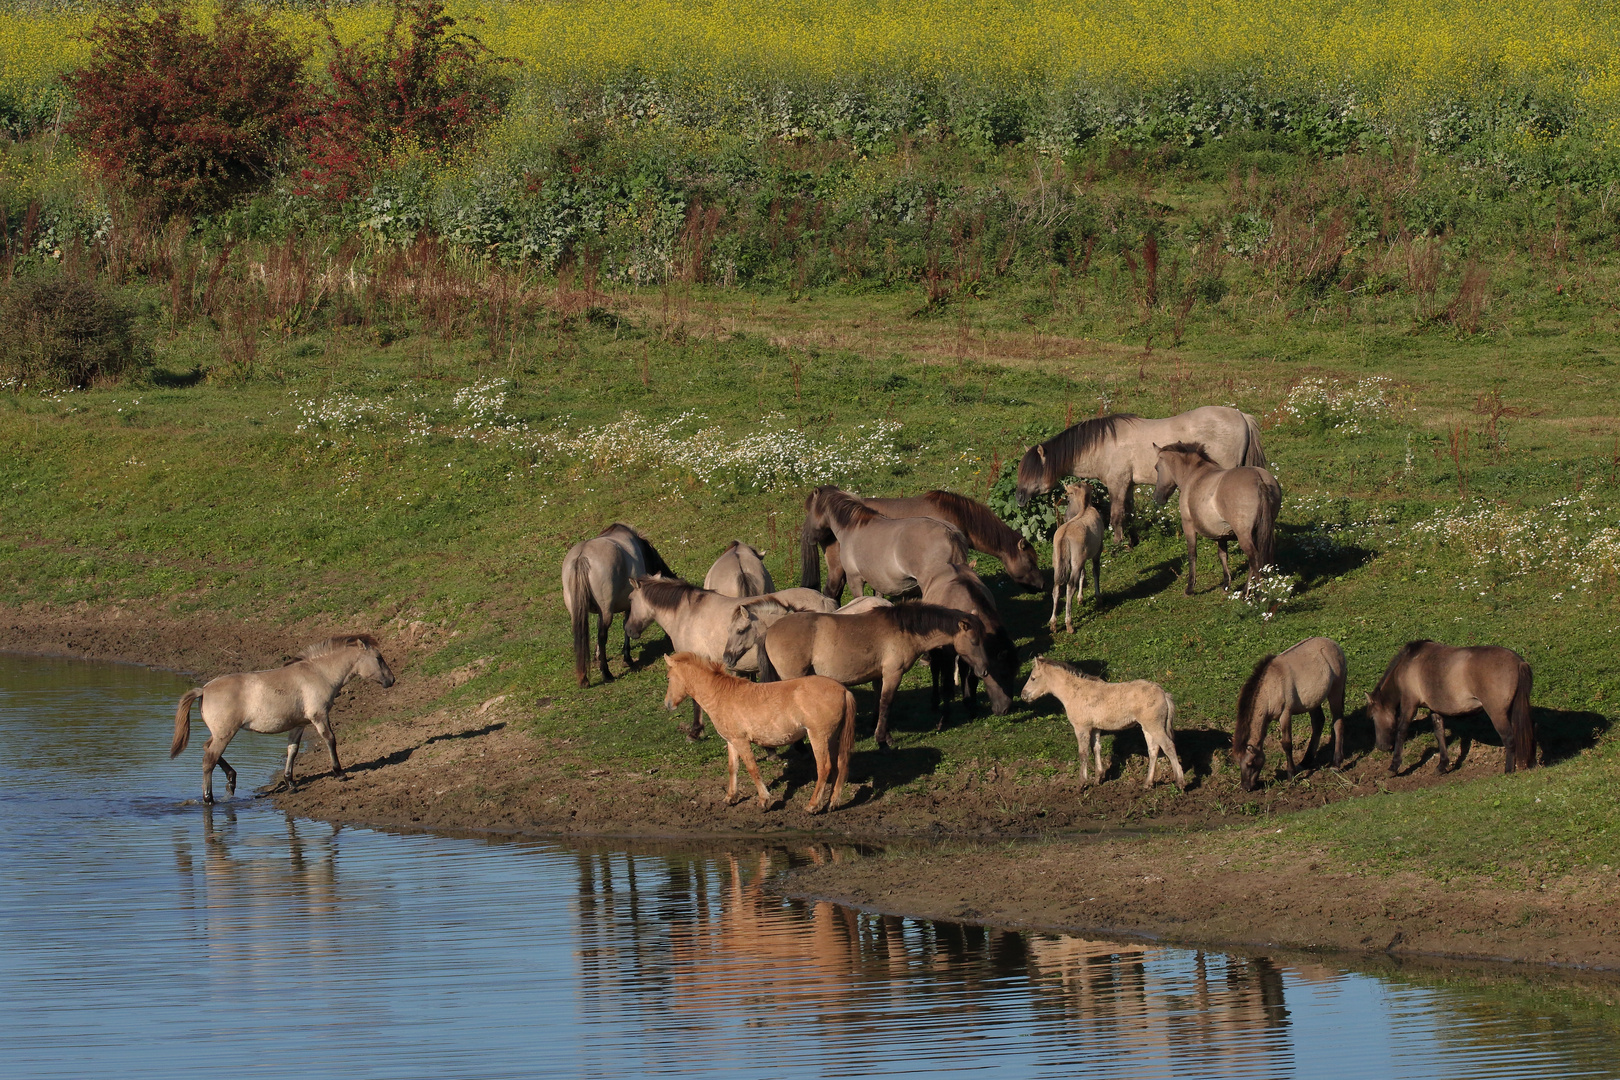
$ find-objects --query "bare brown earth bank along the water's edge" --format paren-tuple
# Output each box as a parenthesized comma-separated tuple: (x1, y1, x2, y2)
(0, 606, 1620, 968)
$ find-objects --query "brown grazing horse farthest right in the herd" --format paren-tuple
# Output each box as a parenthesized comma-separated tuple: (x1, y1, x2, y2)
(1367, 641, 1536, 776)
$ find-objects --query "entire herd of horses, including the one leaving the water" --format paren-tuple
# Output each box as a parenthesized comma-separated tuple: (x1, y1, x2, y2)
(170, 406, 1536, 813)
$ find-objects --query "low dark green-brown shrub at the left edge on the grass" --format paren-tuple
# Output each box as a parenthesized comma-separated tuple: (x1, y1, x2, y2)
(0, 277, 147, 387)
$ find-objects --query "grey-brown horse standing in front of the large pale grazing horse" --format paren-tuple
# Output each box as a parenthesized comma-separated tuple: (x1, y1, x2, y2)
(1153, 442, 1283, 599)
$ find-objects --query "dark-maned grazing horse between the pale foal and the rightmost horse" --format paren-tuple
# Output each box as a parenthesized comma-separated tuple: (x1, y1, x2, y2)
(1231, 638, 1345, 792)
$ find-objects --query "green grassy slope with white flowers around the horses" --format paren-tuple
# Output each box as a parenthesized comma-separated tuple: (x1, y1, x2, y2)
(0, 139, 1620, 878)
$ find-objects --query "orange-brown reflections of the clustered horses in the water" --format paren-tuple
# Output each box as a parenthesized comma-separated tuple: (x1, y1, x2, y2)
(577, 845, 1315, 1075)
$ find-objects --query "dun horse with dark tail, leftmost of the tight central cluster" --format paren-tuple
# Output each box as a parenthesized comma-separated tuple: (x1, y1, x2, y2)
(562, 523, 676, 687)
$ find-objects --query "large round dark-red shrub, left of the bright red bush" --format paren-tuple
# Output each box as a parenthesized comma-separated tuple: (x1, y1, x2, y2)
(63, 0, 309, 214)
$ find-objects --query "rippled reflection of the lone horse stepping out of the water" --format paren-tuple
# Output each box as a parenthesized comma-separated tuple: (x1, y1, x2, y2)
(175, 805, 345, 963)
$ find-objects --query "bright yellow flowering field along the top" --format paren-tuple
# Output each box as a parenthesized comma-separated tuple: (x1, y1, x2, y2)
(0, 0, 1620, 130)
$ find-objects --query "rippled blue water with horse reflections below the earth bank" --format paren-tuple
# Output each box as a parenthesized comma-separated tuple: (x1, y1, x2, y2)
(0, 654, 1620, 1080)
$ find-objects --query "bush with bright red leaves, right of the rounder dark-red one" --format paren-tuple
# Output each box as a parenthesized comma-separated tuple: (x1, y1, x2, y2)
(303, 0, 502, 201)
